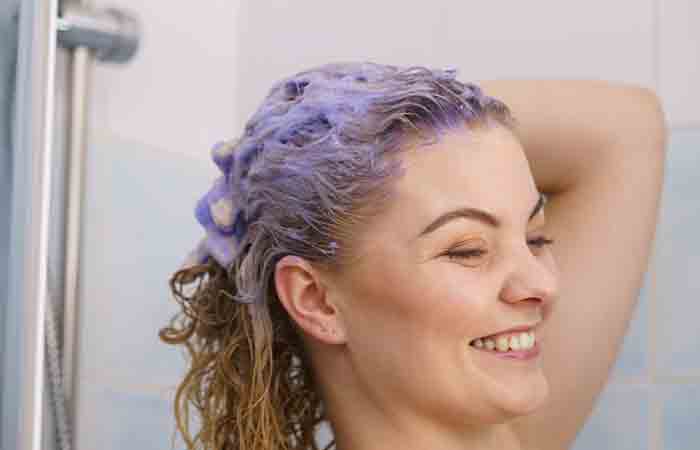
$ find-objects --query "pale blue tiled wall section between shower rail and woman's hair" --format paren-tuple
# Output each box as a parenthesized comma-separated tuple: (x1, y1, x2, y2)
(75, 135, 214, 450)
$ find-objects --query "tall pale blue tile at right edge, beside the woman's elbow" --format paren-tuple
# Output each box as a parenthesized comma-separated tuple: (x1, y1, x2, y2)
(655, 130, 700, 375)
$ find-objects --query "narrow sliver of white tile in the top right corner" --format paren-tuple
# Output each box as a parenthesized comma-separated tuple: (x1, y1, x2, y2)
(659, 0, 700, 126)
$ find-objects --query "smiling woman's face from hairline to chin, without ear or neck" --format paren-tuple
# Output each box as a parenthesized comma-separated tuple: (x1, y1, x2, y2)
(326, 126, 557, 425)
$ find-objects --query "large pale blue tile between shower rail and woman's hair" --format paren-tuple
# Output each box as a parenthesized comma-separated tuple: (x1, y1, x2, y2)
(78, 134, 215, 384)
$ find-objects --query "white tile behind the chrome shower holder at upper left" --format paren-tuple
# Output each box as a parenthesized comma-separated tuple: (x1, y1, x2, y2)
(89, 0, 239, 159)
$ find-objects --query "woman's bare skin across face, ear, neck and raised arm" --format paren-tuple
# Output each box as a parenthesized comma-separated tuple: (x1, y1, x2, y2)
(275, 81, 665, 450)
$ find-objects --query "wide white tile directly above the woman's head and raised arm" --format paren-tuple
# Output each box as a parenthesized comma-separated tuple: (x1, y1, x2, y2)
(235, 0, 654, 126)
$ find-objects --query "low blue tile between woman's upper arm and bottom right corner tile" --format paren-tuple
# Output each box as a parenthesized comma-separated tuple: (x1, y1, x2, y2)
(572, 384, 650, 450)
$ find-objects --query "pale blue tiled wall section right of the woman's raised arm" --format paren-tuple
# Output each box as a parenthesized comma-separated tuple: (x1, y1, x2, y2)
(574, 127, 700, 450)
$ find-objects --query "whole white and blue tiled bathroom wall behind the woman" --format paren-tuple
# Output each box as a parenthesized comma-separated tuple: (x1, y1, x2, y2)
(76, 0, 700, 450)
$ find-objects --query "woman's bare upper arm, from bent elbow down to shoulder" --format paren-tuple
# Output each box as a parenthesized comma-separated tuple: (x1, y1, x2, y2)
(506, 90, 667, 450)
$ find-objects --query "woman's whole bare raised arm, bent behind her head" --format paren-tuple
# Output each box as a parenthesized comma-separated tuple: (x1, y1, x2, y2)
(477, 80, 667, 450)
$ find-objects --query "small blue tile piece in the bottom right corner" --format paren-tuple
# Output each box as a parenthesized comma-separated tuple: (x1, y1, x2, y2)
(660, 385, 700, 450)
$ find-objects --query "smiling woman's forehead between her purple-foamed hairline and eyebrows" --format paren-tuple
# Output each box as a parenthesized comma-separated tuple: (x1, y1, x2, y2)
(346, 126, 539, 253)
